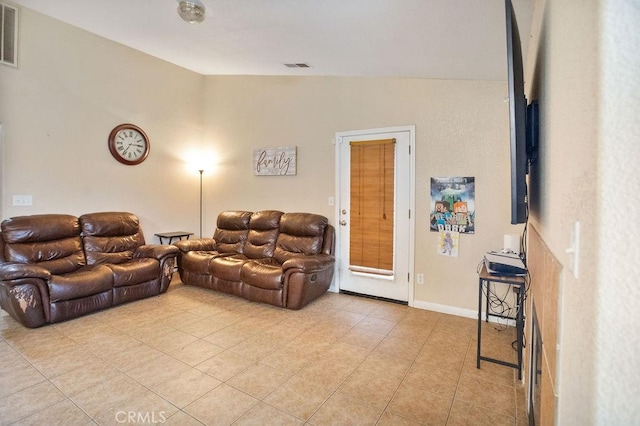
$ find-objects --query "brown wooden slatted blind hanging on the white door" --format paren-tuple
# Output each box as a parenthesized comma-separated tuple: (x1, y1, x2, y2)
(349, 138, 396, 276)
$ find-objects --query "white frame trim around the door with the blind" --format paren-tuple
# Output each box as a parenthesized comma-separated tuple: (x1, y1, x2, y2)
(334, 125, 416, 306)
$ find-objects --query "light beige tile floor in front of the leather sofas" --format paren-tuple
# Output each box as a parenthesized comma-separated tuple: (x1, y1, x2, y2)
(0, 274, 528, 426)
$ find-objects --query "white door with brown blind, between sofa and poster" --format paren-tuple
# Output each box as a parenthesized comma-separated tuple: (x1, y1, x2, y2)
(336, 126, 415, 302)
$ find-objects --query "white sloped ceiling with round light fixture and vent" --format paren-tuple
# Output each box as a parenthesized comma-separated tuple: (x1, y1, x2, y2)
(13, 0, 533, 80)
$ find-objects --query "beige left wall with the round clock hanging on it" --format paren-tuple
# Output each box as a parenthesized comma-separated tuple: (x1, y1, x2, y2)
(0, 9, 203, 242)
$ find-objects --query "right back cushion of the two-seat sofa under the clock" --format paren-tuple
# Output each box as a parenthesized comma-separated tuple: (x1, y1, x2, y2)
(79, 212, 145, 265)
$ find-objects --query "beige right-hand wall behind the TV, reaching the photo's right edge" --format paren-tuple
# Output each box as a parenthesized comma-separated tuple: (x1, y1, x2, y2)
(528, 0, 640, 425)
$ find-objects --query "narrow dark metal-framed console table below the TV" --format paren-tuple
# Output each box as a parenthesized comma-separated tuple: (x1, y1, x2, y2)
(477, 264, 526, 380)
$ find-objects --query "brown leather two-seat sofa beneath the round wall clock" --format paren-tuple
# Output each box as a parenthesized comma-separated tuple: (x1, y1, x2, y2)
(0, 212, 178, 327)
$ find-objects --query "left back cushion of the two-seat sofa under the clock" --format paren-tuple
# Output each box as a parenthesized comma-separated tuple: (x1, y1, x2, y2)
(2, 214, 86, 274)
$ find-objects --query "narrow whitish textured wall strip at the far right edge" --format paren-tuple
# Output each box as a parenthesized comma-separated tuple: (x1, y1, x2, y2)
(596, 0, 640, 425)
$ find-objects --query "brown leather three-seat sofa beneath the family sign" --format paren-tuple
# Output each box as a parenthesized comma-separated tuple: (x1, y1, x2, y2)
(174, 210, 335, 309)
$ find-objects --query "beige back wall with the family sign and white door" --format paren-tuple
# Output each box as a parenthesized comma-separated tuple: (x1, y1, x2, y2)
(204, 76, 521, 316)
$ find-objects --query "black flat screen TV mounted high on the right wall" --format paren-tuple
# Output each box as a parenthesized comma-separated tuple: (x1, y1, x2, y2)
(505, 0, 528, 225)
